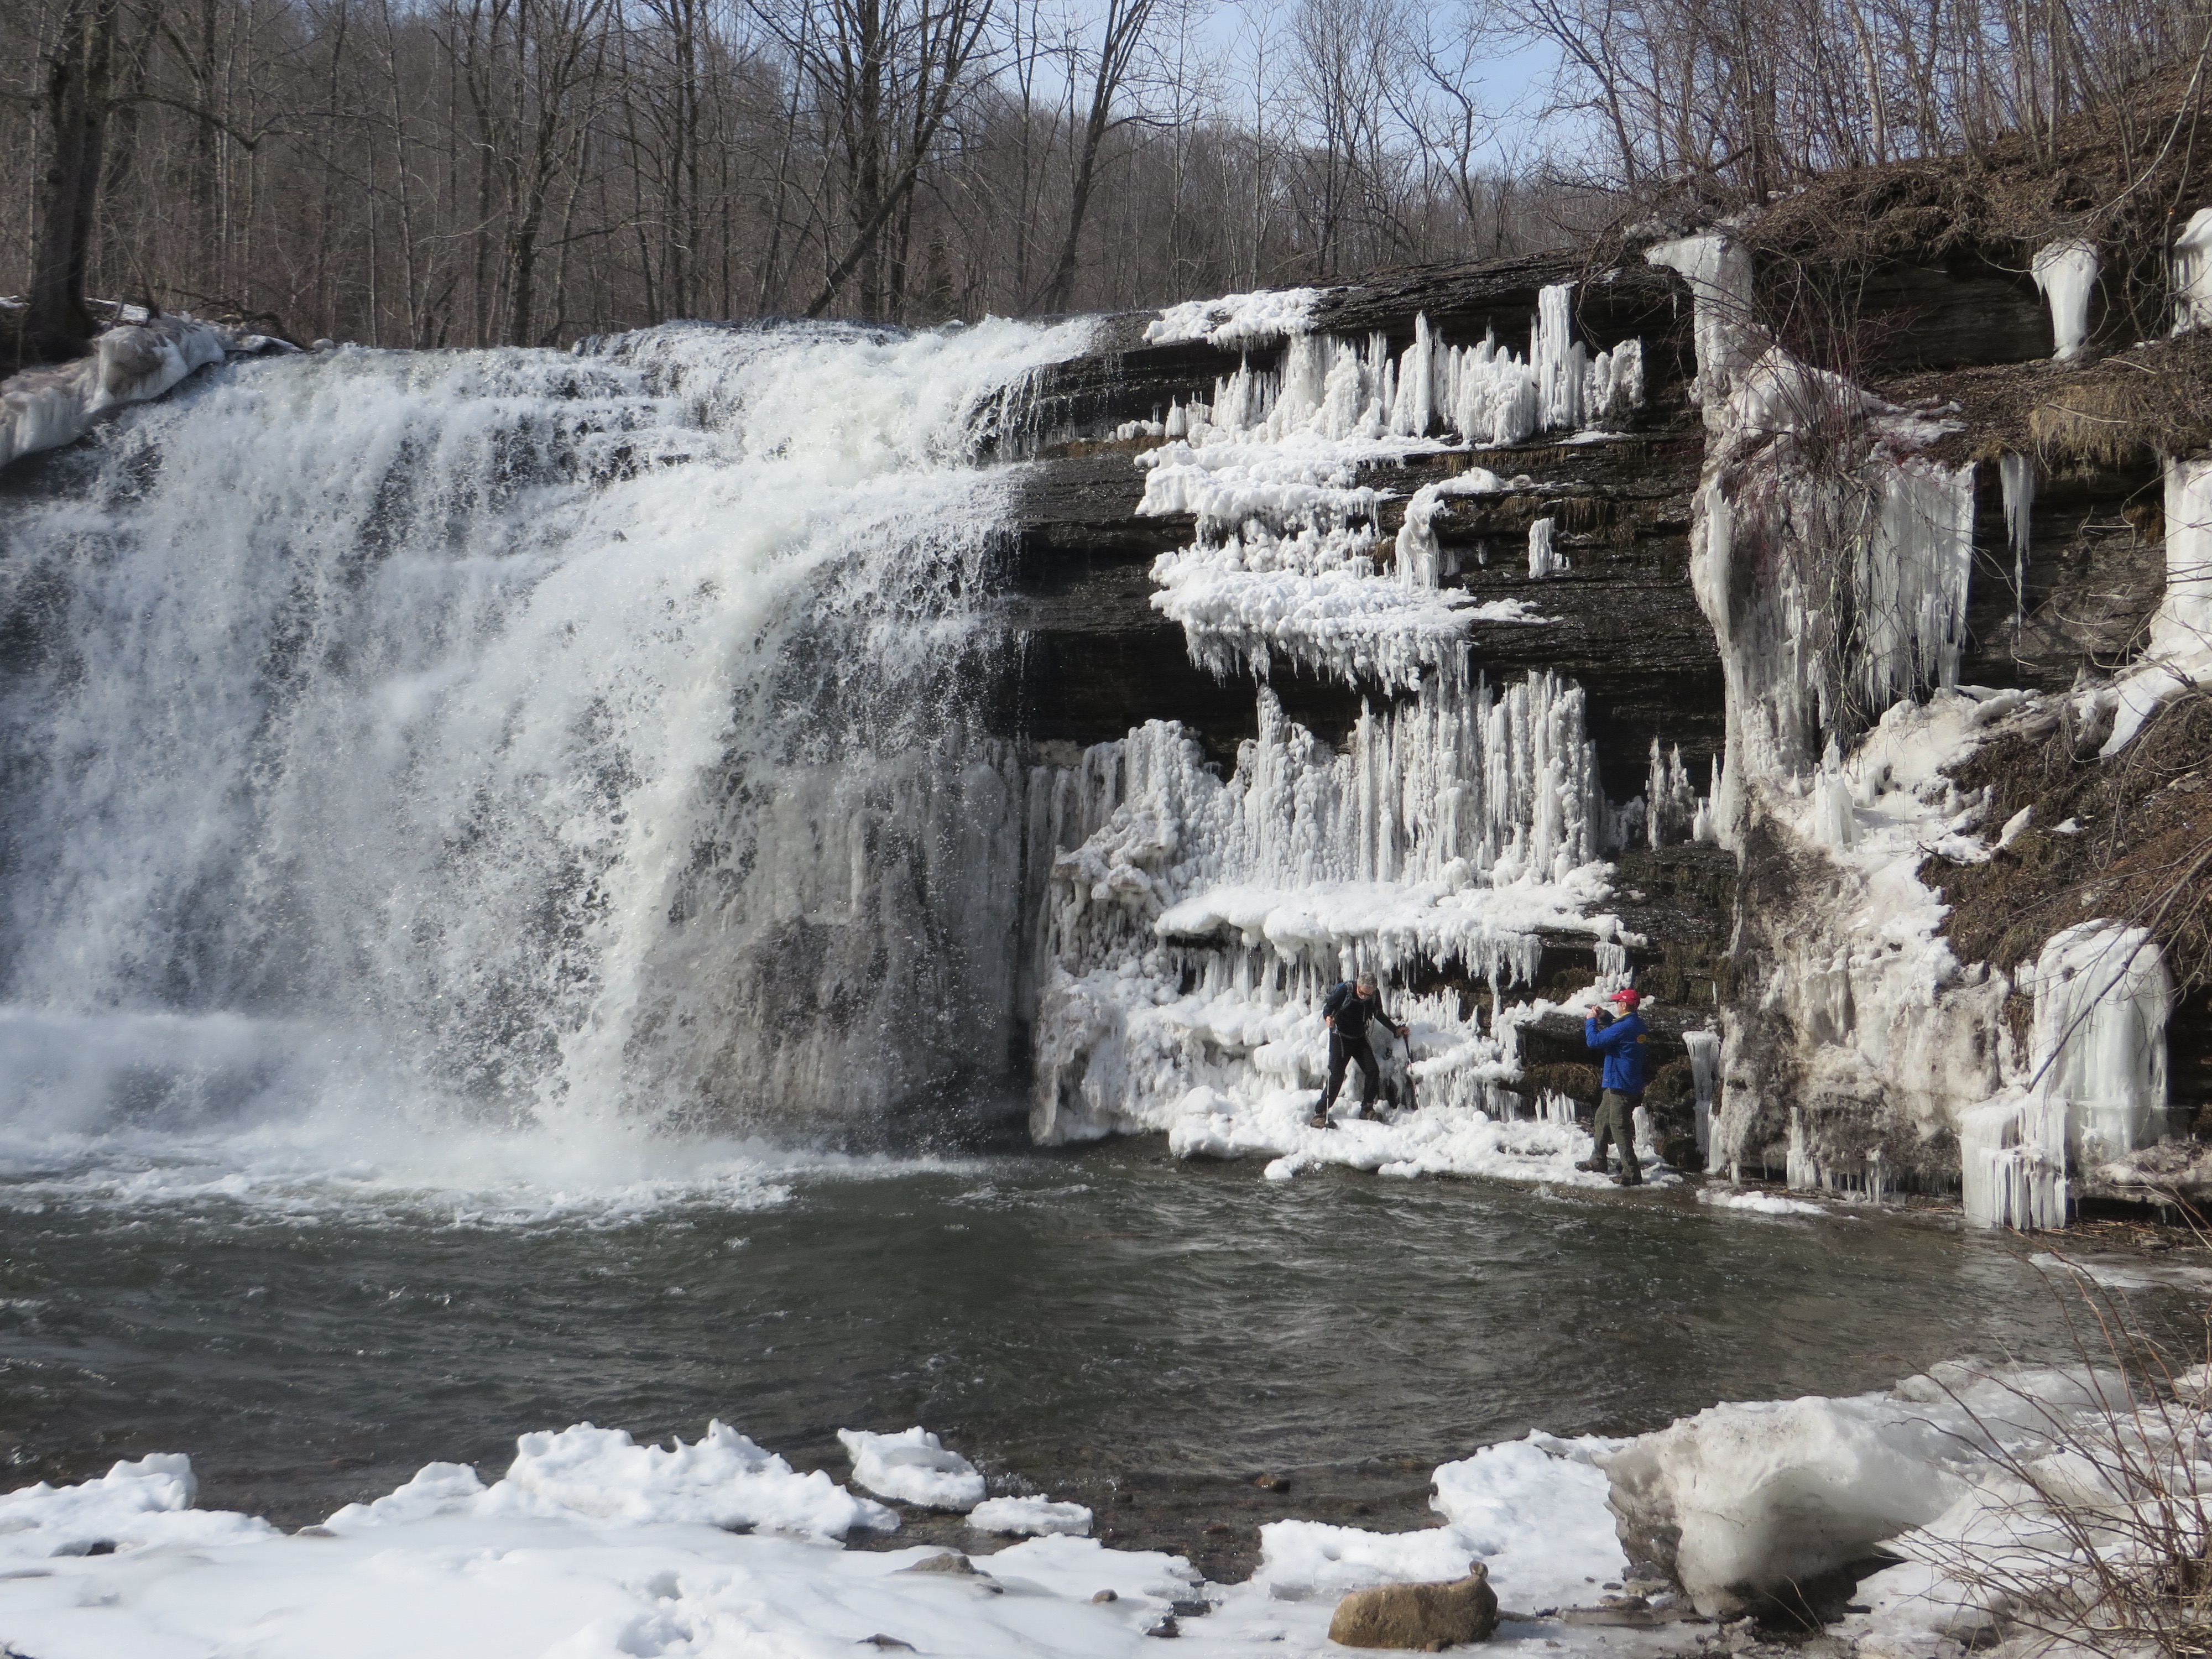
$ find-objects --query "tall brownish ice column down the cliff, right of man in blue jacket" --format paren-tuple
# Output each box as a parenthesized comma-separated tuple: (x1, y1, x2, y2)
(1648, 232, 2057, 1194)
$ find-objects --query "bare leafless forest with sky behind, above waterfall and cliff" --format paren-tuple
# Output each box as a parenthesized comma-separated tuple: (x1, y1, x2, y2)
(0, 0, 2212, 345)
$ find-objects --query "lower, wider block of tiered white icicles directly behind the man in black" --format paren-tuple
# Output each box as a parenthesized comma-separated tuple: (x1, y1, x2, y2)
(1031, 657, 1617, 1141)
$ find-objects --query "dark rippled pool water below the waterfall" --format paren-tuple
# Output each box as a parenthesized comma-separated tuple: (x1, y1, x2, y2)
(0, 1141, 2132, 1568)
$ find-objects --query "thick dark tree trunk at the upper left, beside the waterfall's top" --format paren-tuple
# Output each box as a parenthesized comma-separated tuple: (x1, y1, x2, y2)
(22, 0, 117, 363)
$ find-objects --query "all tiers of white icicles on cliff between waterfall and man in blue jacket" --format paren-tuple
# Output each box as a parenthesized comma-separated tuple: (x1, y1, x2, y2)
(1029, 283, 1644, 1181)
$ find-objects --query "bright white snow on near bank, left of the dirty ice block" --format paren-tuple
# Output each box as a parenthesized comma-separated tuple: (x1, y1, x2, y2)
(0, 1429, 1690, 1659)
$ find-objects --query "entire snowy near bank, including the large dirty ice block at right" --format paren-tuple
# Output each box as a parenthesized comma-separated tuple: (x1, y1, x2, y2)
(0, 1363, 2159, 1659)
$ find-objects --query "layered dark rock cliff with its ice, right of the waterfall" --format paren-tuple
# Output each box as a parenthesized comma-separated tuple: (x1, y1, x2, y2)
(1006, 237, 2212, 1221)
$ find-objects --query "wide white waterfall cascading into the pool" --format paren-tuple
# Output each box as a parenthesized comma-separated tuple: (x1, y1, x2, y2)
(0, 323, 1084, 1168)
